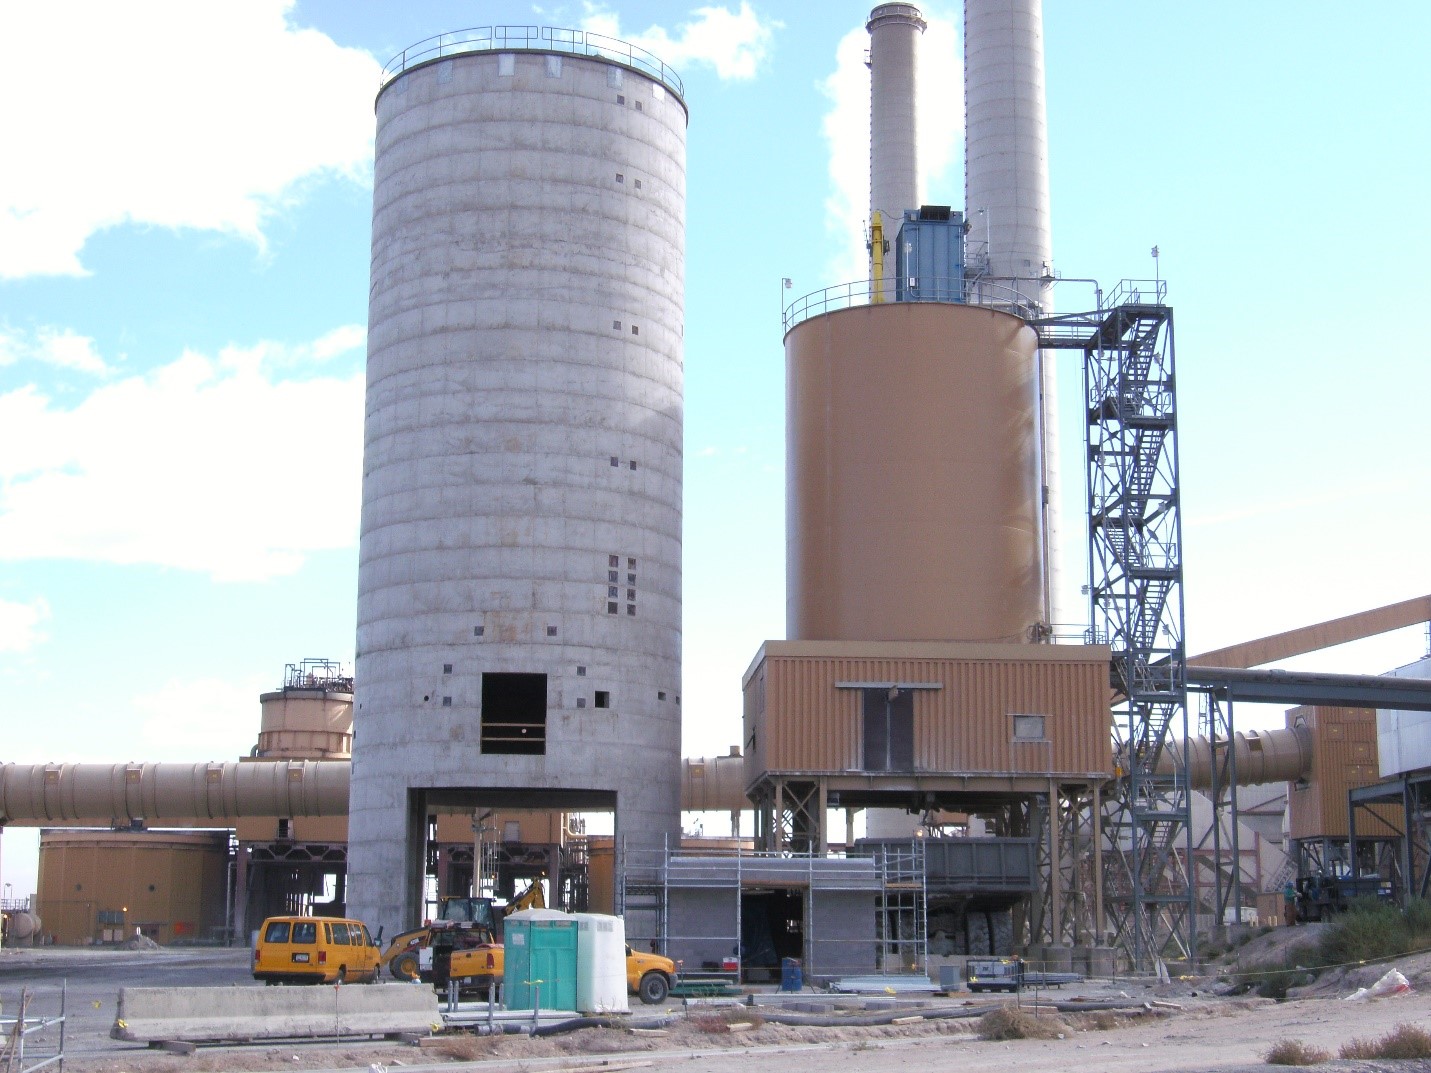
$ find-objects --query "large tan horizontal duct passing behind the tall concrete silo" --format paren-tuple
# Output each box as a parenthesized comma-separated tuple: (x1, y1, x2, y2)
(0, 754, 751, 827)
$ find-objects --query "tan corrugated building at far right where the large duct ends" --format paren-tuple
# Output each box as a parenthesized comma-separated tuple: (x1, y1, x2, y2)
(1286, 707, 1400, 840)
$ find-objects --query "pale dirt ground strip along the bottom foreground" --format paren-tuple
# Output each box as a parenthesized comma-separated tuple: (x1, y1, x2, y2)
(8, 929, 1431, 1073)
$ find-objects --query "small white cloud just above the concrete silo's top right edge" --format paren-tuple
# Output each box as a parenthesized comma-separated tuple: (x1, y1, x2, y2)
(581, 0, 784, 80)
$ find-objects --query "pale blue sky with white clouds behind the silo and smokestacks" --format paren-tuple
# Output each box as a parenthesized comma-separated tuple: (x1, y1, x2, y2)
(0, 0, 1431, 896)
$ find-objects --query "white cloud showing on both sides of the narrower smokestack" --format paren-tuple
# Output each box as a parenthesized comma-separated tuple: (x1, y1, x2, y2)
(820, 10, 964, 280)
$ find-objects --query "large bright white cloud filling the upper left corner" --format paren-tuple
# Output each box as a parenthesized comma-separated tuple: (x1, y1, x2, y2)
(0, 0, 379, 279)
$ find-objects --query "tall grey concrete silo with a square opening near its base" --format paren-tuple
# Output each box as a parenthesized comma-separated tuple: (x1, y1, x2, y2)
(349, 27, 687, 927)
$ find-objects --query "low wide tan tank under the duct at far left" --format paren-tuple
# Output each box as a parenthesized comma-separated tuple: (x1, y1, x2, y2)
(36, 830, 229, 944)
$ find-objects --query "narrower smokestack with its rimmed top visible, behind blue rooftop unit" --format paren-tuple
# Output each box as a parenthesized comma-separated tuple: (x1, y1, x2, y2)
(864, 4, 926, 226)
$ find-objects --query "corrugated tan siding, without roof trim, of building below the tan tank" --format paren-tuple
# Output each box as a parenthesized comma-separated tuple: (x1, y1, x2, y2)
(747, 657, 1112, 774)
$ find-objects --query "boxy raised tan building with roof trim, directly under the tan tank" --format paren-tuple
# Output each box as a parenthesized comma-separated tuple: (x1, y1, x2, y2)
(746, 641, 1113, 784)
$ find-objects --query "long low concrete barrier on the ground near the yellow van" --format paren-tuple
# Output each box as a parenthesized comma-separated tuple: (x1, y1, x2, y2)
(109, 983, 442, 1043)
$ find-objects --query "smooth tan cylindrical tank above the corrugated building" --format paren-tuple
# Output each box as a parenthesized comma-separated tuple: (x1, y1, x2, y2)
(786, 302, 1047, 642)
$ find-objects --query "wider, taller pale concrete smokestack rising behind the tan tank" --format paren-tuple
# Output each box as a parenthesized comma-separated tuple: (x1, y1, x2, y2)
(964, 0, 1065, 622)
